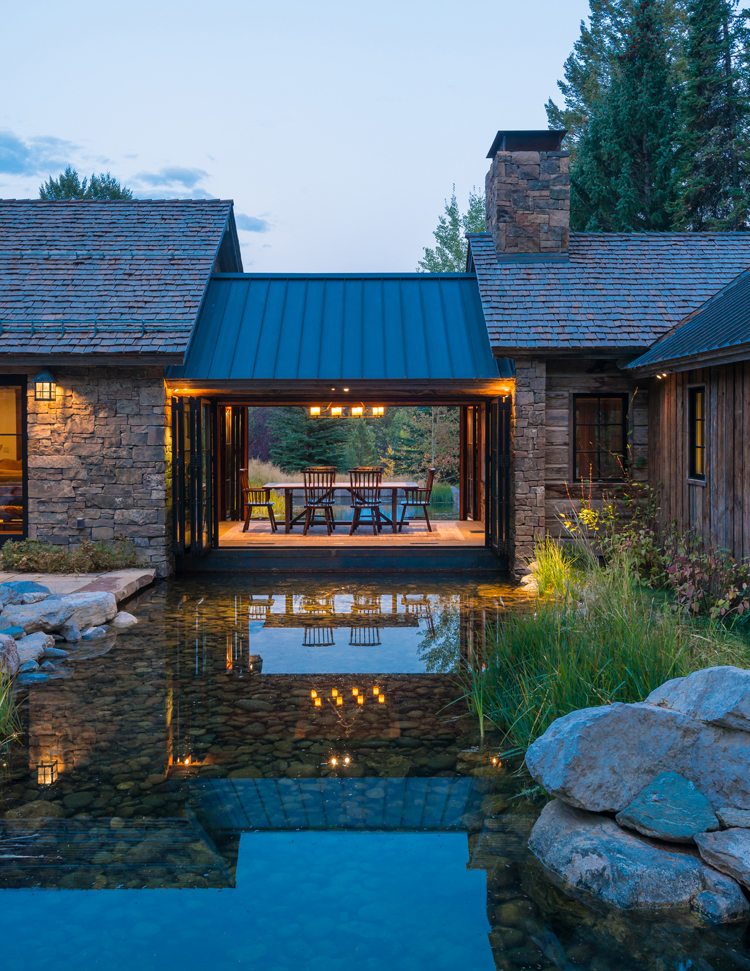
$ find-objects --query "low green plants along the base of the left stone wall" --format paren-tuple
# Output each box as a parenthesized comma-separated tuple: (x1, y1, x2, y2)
(0, 539, 142, 573)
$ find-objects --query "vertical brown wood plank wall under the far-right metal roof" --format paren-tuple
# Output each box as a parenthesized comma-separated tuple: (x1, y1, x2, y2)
(649, 361, 750, 559)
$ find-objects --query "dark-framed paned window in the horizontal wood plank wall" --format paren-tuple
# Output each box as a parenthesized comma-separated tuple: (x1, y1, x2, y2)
(573, 394, 628, 482)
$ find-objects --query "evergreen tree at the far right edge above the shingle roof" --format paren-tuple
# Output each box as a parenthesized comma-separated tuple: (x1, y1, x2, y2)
(675, 0, 750, 231)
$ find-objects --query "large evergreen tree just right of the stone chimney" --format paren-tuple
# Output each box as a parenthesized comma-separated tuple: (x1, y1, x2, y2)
(571, 0, 678, 232)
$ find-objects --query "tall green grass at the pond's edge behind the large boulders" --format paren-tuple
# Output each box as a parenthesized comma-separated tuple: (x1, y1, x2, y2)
(466, 540, 750, 751)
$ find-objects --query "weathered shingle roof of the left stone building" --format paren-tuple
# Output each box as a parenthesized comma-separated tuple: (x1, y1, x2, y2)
(0, 200, 242, 356)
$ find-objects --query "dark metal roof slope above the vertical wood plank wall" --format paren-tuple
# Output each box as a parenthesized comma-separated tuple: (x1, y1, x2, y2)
(629, 271, 750, 370)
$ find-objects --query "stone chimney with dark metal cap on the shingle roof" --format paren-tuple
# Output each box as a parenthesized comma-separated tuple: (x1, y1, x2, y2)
(485, 131, 570, 256)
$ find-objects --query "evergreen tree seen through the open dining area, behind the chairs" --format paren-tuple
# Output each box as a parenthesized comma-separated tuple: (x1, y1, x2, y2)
(270, 408, 347, 472)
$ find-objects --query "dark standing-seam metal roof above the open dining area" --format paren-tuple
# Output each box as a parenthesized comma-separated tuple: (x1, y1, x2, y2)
(169, 273, 498, 381)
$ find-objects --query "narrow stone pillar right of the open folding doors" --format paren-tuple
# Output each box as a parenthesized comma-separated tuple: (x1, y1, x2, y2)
(511, 359, 547, 571)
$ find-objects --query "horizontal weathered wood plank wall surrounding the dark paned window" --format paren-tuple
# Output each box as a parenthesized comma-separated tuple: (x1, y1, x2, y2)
(545, 359, 648, 536)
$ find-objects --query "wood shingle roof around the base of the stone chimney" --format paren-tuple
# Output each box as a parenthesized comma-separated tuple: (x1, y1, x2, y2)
(469, 233, 750, 353)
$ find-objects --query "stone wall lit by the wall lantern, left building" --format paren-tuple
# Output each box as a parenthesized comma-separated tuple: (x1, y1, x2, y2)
(28, 367, 171, 576)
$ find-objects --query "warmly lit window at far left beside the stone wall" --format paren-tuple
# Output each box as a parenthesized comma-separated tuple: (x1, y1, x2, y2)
(0, 378, 26, 542)
